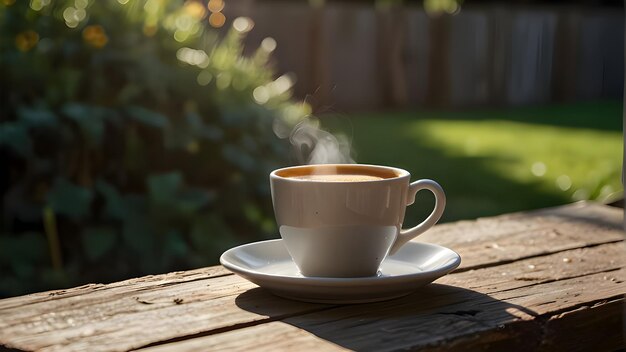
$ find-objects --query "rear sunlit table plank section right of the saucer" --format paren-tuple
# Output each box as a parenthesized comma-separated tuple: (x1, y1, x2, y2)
(417, 202, 624, 270)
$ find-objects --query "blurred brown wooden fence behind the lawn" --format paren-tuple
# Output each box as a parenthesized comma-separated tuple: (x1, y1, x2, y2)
(225, 0, 624, 111)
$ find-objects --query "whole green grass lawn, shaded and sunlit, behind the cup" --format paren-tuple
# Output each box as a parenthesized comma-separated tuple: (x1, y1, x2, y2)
(320, 102, 623, 226)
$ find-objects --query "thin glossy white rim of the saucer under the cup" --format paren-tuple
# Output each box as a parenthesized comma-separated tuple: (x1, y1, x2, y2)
(220, 238, 461, 286)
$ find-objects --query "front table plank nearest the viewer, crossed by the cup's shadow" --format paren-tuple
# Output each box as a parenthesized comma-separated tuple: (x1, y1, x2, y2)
(142, 269, 626, 352)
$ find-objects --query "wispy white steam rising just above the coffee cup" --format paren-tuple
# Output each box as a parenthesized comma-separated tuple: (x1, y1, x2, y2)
(274, 117, 355, 164)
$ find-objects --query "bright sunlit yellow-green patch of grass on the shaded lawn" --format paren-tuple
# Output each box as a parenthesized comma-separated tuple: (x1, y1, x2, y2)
(406, 120, 622, 201)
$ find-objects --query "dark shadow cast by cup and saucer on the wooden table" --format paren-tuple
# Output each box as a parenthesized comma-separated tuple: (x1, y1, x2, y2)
(235, 284, 541, 350)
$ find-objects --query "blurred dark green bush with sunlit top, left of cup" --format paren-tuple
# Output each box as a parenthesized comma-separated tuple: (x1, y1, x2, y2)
(0, 0, 308, 296)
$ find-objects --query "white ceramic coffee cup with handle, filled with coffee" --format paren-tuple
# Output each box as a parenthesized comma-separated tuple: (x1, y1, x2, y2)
(270, 164, 446, 277)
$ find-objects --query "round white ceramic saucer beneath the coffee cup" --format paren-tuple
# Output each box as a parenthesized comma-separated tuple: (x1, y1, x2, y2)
(220, 240, 461, 304)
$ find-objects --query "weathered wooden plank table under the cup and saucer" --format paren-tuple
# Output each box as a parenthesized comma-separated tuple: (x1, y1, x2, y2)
(0, 203, 626, 351)
